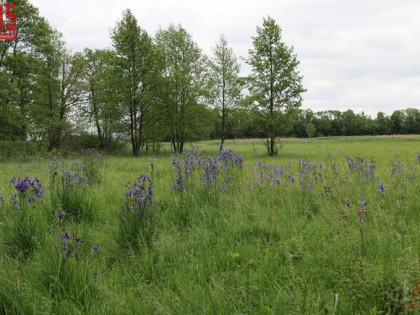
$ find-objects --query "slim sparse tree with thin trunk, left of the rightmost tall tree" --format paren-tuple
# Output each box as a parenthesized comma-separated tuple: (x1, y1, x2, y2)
(209, 35, 241, 151)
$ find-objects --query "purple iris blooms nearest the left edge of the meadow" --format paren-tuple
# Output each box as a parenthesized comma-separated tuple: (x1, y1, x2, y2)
(9, 176, 45, 206)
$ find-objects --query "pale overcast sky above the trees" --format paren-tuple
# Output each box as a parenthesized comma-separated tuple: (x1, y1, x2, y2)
(32, 0, 420, 115)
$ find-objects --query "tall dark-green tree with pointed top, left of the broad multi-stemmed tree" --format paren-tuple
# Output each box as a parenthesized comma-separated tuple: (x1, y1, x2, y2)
(111, 10, 160, 156)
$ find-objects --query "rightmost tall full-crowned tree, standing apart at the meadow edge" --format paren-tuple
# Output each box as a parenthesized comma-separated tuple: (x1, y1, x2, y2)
(247, 17, 305, 155)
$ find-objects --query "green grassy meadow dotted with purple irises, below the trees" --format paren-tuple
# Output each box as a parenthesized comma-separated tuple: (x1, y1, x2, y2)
(0, 136, 420, 314)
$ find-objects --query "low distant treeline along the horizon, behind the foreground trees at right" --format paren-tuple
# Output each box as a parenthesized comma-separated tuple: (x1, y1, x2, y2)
(211, 108, 420, 139)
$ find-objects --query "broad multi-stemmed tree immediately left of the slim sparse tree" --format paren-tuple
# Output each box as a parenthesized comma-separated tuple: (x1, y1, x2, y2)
(156, 25, 210, 152)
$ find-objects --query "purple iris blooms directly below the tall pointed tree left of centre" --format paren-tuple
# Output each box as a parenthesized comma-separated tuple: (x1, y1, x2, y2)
(122, 174, 154, 219)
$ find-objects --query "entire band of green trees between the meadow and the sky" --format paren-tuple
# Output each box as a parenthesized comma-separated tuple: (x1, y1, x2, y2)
(0, 0, 420, 156)
